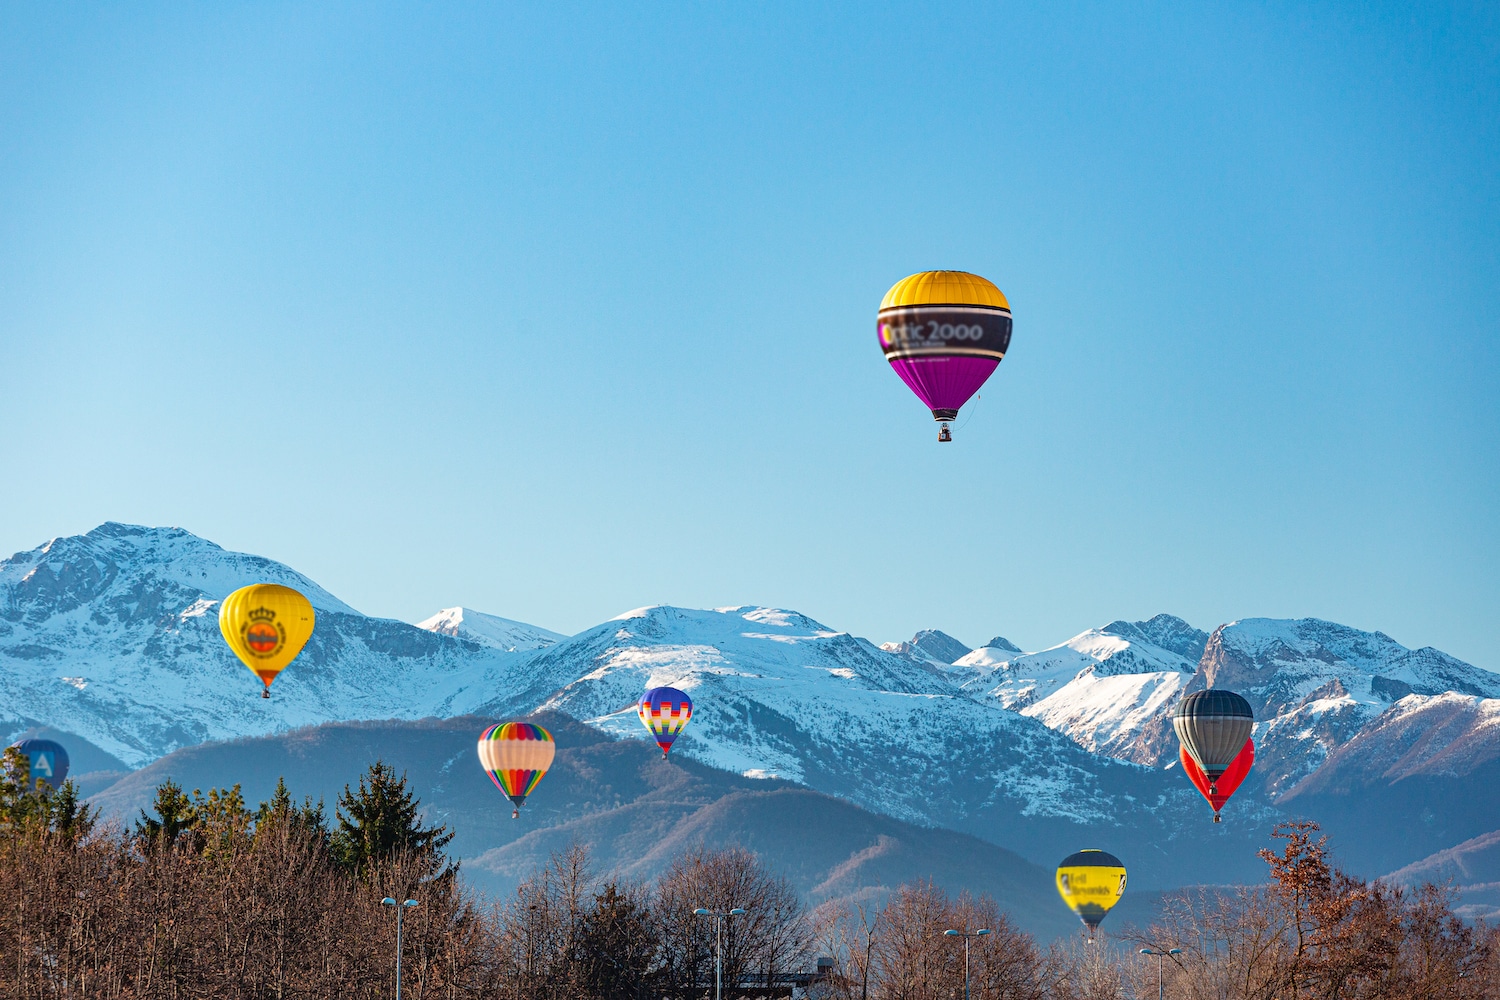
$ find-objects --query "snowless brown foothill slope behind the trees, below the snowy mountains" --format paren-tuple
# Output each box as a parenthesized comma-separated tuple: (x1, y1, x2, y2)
(92, 715, 1074, 939)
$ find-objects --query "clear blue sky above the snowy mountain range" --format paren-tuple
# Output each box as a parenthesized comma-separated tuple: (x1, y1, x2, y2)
(0, 3, 1500, 669)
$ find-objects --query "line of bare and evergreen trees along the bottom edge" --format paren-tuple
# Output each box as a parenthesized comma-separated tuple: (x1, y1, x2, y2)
(0, 751, 1500, 1000)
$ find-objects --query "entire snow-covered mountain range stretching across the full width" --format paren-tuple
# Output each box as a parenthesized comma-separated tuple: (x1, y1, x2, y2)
(0, 523, 1500, 877)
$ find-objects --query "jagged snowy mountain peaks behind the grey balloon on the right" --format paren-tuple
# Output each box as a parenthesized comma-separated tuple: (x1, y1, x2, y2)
(930, 615, 1500, 801)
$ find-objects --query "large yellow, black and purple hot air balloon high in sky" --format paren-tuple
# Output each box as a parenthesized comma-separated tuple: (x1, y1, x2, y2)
(876, 271, 1011, 441)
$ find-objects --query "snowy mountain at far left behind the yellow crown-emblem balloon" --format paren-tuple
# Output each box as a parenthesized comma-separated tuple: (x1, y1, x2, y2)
(0, 523, 531, 766)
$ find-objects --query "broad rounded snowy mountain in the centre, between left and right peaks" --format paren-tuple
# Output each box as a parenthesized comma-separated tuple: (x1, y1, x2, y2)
(468, 607, 1158, 828)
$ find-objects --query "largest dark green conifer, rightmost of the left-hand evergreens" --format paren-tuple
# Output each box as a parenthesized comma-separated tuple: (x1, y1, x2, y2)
(332, 760, 453, 876)
